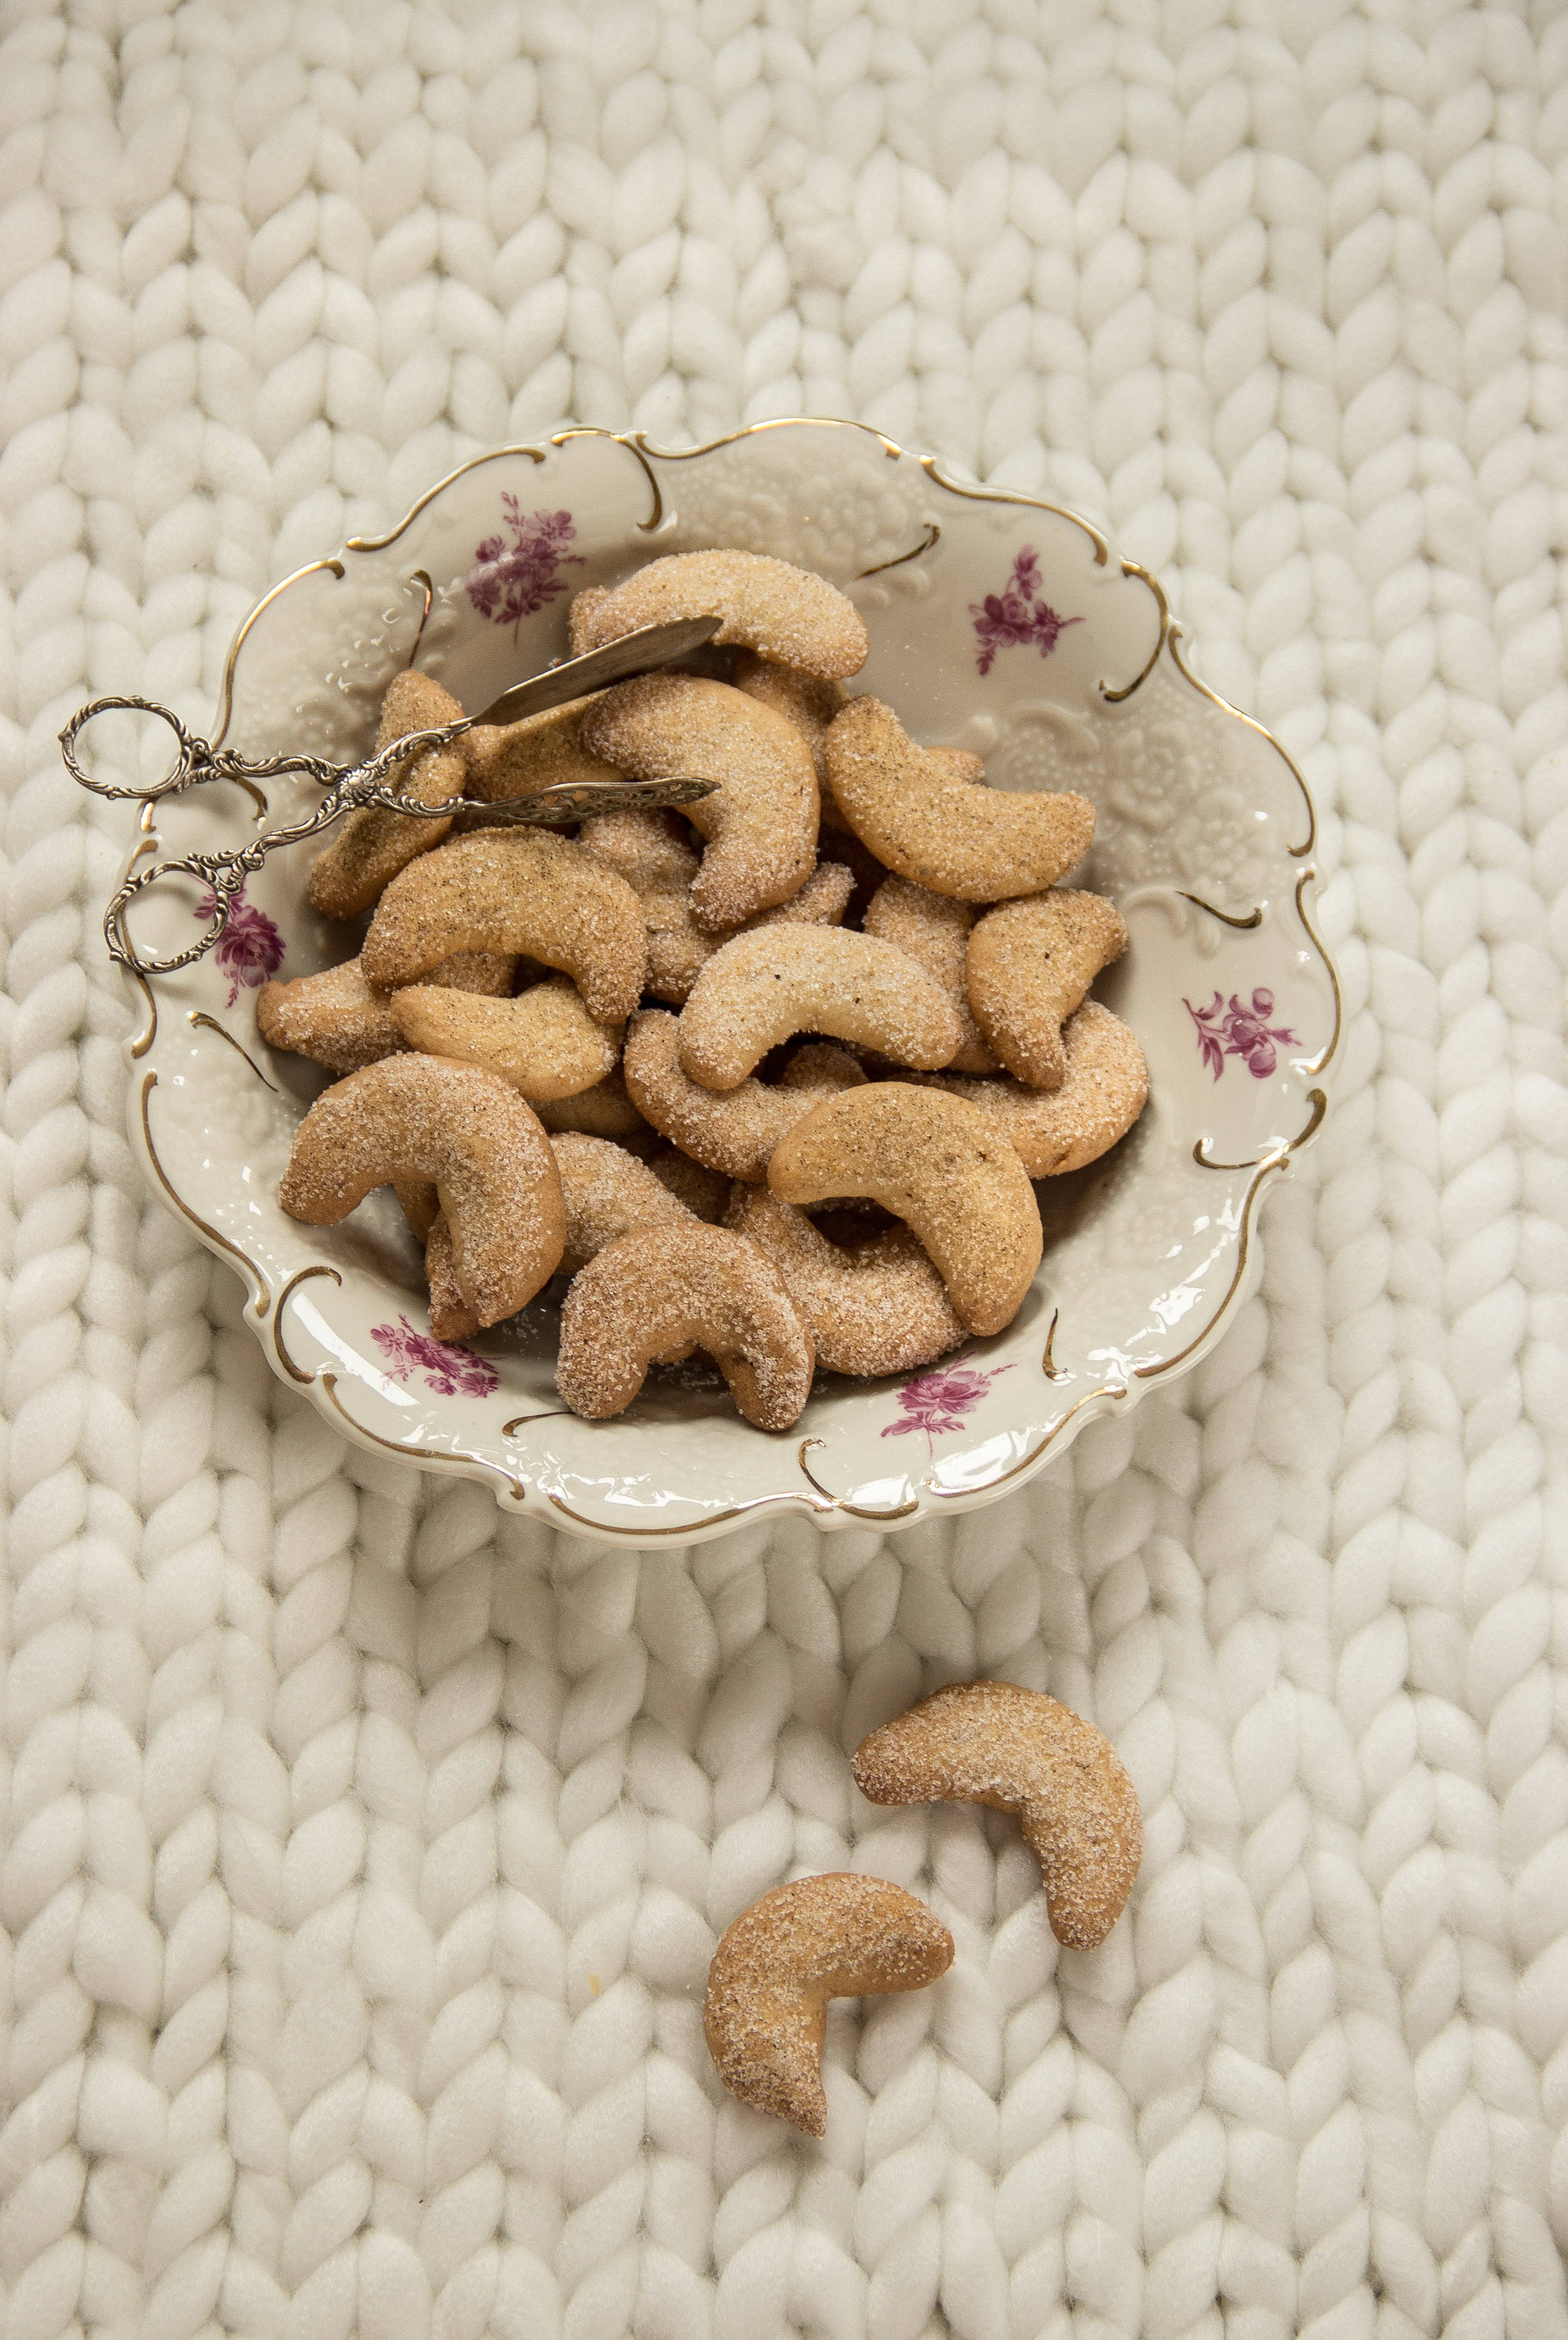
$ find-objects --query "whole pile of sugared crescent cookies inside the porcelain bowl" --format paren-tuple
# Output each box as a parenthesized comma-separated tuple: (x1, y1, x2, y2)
(270, 552, 1147, 1430)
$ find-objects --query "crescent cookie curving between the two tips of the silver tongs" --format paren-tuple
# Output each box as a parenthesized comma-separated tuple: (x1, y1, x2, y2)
(583, 674, 819, 934)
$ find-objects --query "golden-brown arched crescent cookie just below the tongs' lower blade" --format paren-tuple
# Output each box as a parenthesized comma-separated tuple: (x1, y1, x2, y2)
(360, 828, 648, 1022)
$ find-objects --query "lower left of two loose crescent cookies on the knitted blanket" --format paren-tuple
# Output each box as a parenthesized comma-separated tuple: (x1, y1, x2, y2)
(702, 1869, 953, 2136)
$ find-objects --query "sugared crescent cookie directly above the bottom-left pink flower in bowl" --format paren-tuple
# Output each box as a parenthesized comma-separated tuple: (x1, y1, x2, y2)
(278, 1055, 566, 1324)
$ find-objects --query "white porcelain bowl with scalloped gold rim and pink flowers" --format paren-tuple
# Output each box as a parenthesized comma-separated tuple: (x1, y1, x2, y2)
(101, 421, 1339, 1542)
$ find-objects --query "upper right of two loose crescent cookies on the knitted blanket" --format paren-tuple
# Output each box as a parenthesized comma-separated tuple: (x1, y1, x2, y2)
(854, 1683, 1144, 1949)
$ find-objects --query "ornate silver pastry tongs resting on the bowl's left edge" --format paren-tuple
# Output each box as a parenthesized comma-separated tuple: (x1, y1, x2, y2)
(61, 618, 719, 976)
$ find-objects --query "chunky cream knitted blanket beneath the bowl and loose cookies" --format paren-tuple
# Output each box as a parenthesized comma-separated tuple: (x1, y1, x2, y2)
(0, 0, 1568, 2340)
